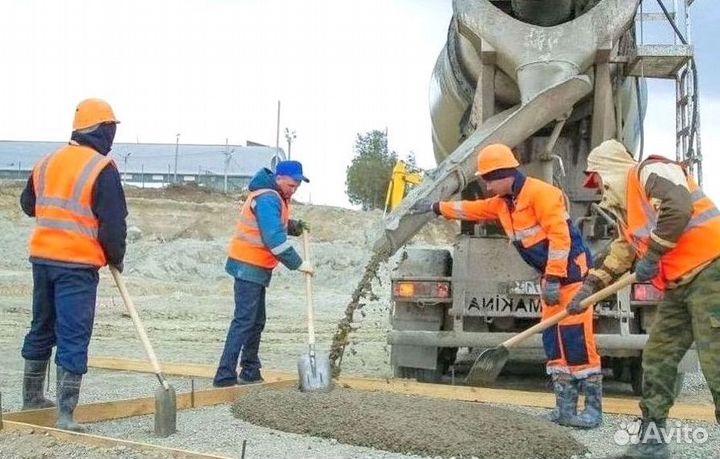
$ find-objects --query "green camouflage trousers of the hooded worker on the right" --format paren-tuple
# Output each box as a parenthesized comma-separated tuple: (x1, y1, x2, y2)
(640, 260, 720, 423)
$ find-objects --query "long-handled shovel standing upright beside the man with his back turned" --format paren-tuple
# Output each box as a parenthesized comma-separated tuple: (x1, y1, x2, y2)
(110, 266, 177, 437)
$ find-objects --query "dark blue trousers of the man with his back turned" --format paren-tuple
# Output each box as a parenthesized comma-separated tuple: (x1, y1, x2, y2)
(22, 263, 99, 374)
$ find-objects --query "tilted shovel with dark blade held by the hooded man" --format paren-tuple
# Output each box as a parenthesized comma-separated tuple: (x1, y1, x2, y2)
(465, 274, 635, 385)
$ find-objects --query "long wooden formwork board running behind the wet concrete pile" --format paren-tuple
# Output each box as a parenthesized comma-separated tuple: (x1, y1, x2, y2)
(90, 358, 716, 422)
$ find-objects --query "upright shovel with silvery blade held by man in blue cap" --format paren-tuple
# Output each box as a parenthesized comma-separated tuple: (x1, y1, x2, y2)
(298, 230, 332, 392)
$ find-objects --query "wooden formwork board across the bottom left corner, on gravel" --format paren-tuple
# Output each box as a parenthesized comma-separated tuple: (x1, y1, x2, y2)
(3, 419, 232, 459)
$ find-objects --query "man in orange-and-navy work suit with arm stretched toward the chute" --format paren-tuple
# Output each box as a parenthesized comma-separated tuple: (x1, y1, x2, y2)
(410, 144, 602, 428)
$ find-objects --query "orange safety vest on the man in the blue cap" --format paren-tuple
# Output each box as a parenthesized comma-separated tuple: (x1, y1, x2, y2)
(229, 188, 290, 269)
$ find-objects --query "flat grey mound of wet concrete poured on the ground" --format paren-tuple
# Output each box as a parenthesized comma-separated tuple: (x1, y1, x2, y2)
(232, 388, 586, 459)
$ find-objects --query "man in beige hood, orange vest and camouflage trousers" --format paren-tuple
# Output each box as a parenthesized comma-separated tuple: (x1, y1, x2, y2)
(568, 140, 720, 459)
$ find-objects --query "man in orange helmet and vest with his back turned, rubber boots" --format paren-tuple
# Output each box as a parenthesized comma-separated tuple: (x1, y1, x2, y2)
(20, 99, 127, 432)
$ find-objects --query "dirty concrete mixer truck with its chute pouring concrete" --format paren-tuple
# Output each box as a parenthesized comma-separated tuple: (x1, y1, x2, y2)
(375, 0, 702, 391)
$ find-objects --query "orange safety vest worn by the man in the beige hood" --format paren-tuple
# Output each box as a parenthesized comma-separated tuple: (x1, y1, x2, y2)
(622, 160, 720, 290)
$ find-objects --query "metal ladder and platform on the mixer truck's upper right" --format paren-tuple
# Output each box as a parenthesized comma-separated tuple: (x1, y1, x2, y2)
(627, 0, 702, 185)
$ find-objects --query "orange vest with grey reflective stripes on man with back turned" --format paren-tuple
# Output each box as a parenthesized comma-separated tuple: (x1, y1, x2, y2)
(30, 145, 112, 267)
